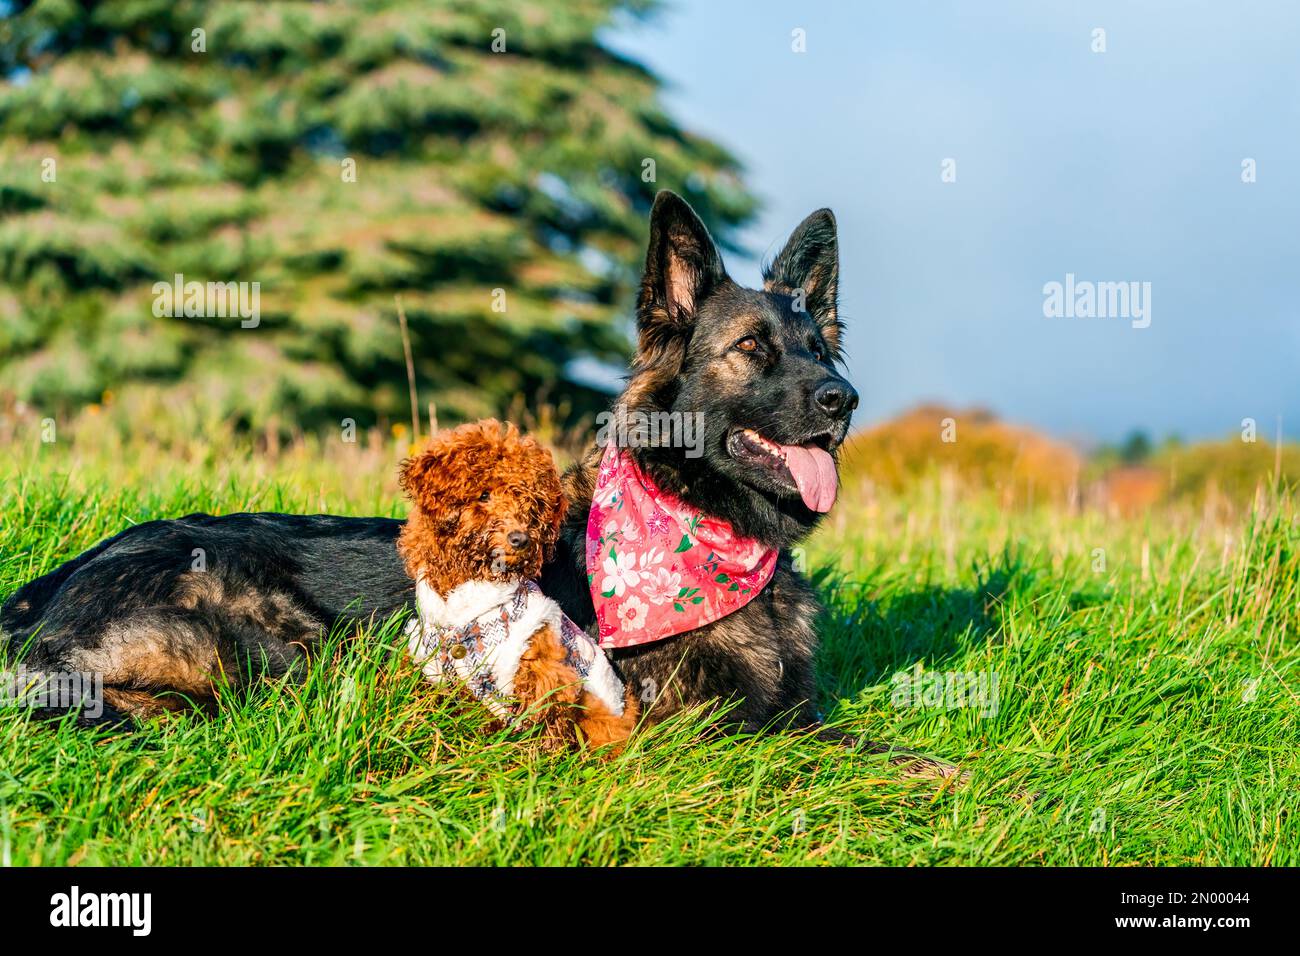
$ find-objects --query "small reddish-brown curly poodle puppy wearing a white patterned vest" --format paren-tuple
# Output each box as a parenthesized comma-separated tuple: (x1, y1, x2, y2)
(398, 419, 638, 747)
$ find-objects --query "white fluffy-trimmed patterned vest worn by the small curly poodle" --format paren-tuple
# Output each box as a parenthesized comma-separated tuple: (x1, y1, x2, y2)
(407, 578, 623, 722)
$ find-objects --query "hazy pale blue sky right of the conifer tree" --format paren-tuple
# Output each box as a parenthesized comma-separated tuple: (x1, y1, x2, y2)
(610, 0, 1300, 442)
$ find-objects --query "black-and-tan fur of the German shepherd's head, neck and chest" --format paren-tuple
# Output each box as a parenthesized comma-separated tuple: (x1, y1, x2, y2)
(541, 193, 858, 730)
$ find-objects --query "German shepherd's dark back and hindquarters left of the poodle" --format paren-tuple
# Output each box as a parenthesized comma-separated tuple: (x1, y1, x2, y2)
(0, 514, 415, 721)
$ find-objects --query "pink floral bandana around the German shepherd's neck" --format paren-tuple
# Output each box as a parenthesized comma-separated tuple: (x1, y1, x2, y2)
(586, 445, 776, 648)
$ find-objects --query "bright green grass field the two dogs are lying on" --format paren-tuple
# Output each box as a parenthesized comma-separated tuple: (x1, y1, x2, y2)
(0, 442, 1300, 865)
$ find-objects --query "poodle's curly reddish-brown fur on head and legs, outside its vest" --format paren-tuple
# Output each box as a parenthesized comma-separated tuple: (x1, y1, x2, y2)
(398, 419, 640, 749)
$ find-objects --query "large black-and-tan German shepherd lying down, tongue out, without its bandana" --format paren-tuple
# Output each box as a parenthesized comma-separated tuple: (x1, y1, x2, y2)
(0, 191, 941, 770)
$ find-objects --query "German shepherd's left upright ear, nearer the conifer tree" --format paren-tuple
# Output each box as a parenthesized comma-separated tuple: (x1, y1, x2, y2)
(637, 190, 727, 338)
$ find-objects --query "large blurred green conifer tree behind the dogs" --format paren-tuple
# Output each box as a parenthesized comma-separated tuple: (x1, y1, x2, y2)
(0, 0, 753, 428)
